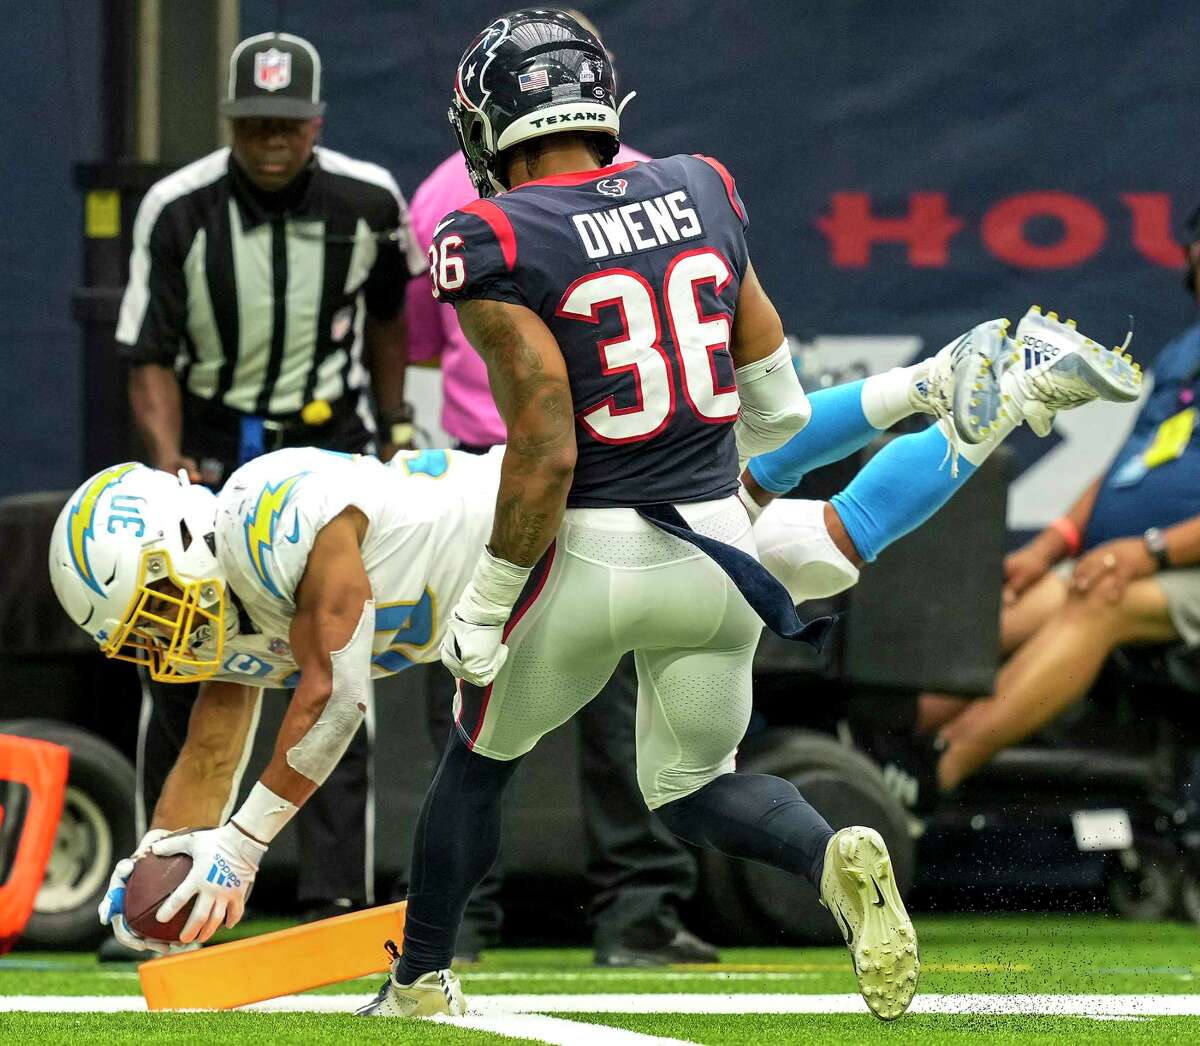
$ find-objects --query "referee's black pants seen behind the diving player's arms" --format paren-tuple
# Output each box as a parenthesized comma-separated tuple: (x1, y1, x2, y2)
(137, 674, 374, 906)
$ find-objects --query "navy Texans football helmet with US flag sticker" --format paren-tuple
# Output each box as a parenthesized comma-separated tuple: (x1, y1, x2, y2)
(446, 8, 620, 197)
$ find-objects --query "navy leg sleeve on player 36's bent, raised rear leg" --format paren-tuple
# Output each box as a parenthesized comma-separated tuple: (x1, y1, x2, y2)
(658, 774, 833, 890)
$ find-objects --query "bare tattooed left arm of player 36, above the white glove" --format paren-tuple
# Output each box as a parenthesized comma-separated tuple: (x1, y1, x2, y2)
(457, 300, 575, 566)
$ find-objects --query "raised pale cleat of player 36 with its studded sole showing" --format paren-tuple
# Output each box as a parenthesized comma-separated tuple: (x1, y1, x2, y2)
(821, 825, 920, 1021)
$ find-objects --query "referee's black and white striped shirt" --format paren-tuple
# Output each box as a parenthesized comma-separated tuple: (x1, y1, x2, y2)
(116, 146, 425, 417)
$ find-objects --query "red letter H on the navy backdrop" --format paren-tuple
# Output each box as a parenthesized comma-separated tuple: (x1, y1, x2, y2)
(816, 192, 962, 269)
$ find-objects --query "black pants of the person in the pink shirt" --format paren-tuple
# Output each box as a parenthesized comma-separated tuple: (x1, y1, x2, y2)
(426, 654, 696, 952)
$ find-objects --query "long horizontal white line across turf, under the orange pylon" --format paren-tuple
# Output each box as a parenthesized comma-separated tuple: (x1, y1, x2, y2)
(0, 993, 1200, 1017)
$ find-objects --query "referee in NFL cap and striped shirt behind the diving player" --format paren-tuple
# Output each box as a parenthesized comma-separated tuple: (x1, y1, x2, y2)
(108, 34, 424, 954)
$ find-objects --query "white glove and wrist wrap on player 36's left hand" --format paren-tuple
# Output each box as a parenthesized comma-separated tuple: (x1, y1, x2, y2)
(442, 548, 533, 686)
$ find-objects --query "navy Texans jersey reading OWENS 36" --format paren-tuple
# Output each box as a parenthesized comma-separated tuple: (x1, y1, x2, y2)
(430, 156, 749, 507)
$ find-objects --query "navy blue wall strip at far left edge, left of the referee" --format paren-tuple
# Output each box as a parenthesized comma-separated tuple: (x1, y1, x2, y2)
(0, 0, 103, 494)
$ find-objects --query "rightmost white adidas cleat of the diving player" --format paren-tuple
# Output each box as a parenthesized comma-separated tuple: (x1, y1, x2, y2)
(997, 305, 1141, 435)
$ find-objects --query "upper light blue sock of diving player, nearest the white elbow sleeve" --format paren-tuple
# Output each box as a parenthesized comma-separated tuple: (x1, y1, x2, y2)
(750, 381, 880, 494)
